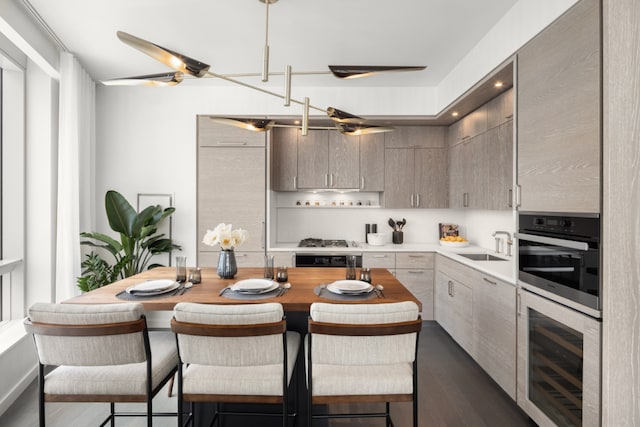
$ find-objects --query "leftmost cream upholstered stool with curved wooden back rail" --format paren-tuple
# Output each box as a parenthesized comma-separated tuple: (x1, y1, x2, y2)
(25, 303, 178, 427)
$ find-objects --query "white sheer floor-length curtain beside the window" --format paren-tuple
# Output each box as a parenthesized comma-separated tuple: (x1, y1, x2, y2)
(55, 52, 95, 301)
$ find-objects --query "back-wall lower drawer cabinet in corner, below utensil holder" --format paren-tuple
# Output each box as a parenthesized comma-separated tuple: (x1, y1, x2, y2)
(396, 252, 435, 320)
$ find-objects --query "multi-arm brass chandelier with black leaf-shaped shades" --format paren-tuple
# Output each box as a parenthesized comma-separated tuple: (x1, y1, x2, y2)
(102, 0, 426, 135)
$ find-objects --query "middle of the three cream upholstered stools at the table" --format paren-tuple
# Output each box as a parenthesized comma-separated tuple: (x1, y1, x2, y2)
(171, 303, 300, 427)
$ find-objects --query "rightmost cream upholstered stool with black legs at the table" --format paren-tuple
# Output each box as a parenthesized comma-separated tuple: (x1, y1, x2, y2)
(305, 301, 422, 427)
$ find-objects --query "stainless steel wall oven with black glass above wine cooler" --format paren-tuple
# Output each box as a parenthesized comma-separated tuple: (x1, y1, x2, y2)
(516, 212, 601, 311)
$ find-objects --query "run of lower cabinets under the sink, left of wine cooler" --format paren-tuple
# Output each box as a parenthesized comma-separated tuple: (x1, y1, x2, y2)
(434, 255, 517, 400)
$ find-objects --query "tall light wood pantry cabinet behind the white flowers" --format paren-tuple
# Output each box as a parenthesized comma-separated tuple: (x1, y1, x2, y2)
(196, 120, 266, 267)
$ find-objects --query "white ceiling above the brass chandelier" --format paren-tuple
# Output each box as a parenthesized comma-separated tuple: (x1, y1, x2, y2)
(26, 0, 517, 86)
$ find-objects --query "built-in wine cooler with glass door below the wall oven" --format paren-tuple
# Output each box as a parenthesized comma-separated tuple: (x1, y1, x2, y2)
(517, 289, 601, 427)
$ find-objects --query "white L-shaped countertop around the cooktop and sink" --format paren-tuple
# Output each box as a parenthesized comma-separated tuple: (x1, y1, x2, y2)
(269, 242, 516, 286)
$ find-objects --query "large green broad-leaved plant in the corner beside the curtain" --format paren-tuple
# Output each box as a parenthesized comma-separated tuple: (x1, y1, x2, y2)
(77, 190, 182, 292)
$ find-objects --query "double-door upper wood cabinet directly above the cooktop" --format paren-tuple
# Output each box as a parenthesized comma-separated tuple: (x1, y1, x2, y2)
(297, 130, 360, 189)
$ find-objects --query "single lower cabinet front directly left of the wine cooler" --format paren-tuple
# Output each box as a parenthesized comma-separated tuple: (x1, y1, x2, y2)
(472, 272, 517, 400)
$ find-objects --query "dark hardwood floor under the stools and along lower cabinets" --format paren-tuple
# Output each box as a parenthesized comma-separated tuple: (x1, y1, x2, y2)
(0, 322, 534, 427)
